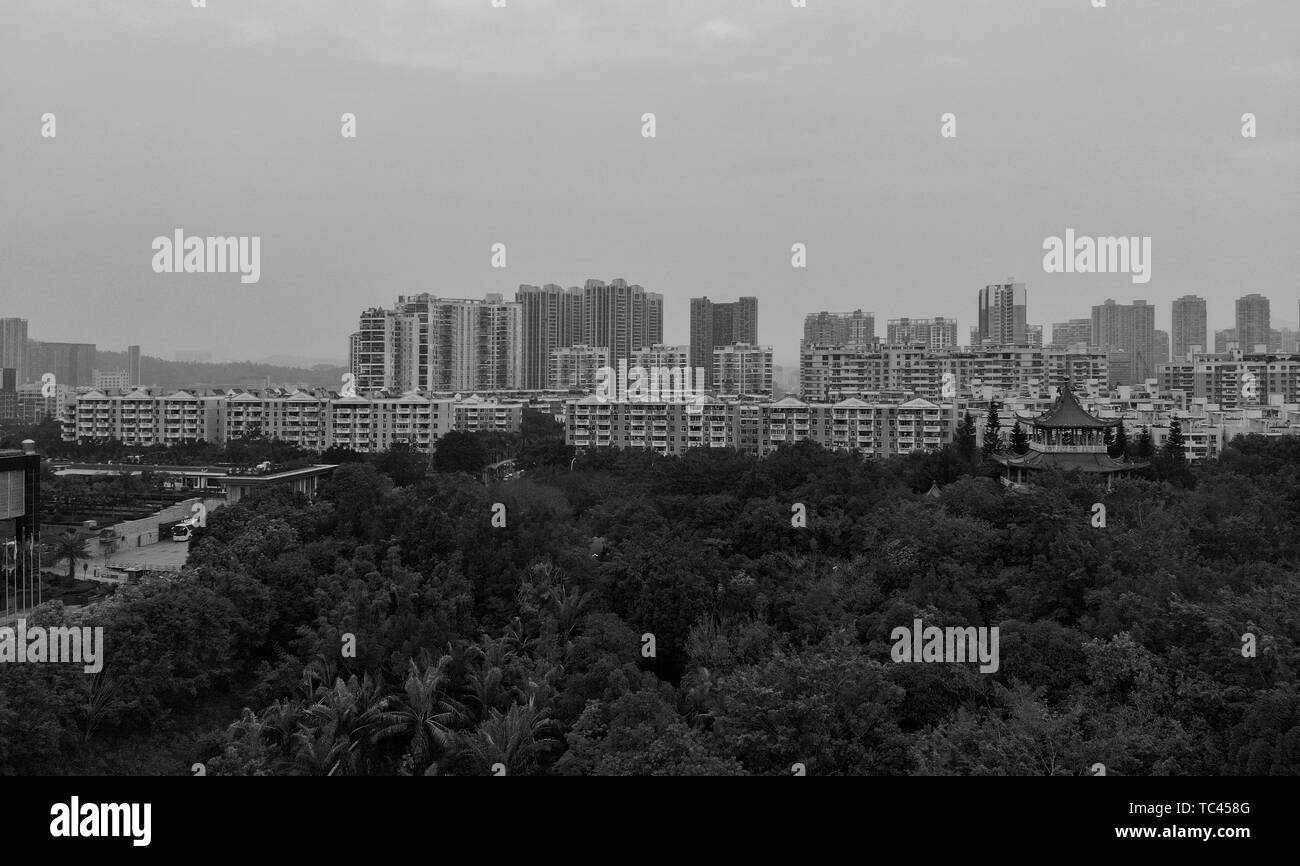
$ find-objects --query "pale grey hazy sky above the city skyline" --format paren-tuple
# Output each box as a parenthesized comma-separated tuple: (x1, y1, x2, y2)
(0, 0, 1300, 364)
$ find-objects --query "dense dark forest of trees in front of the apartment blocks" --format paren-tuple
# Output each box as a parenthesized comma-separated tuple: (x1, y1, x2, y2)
(0, 437, 1300, 775)
